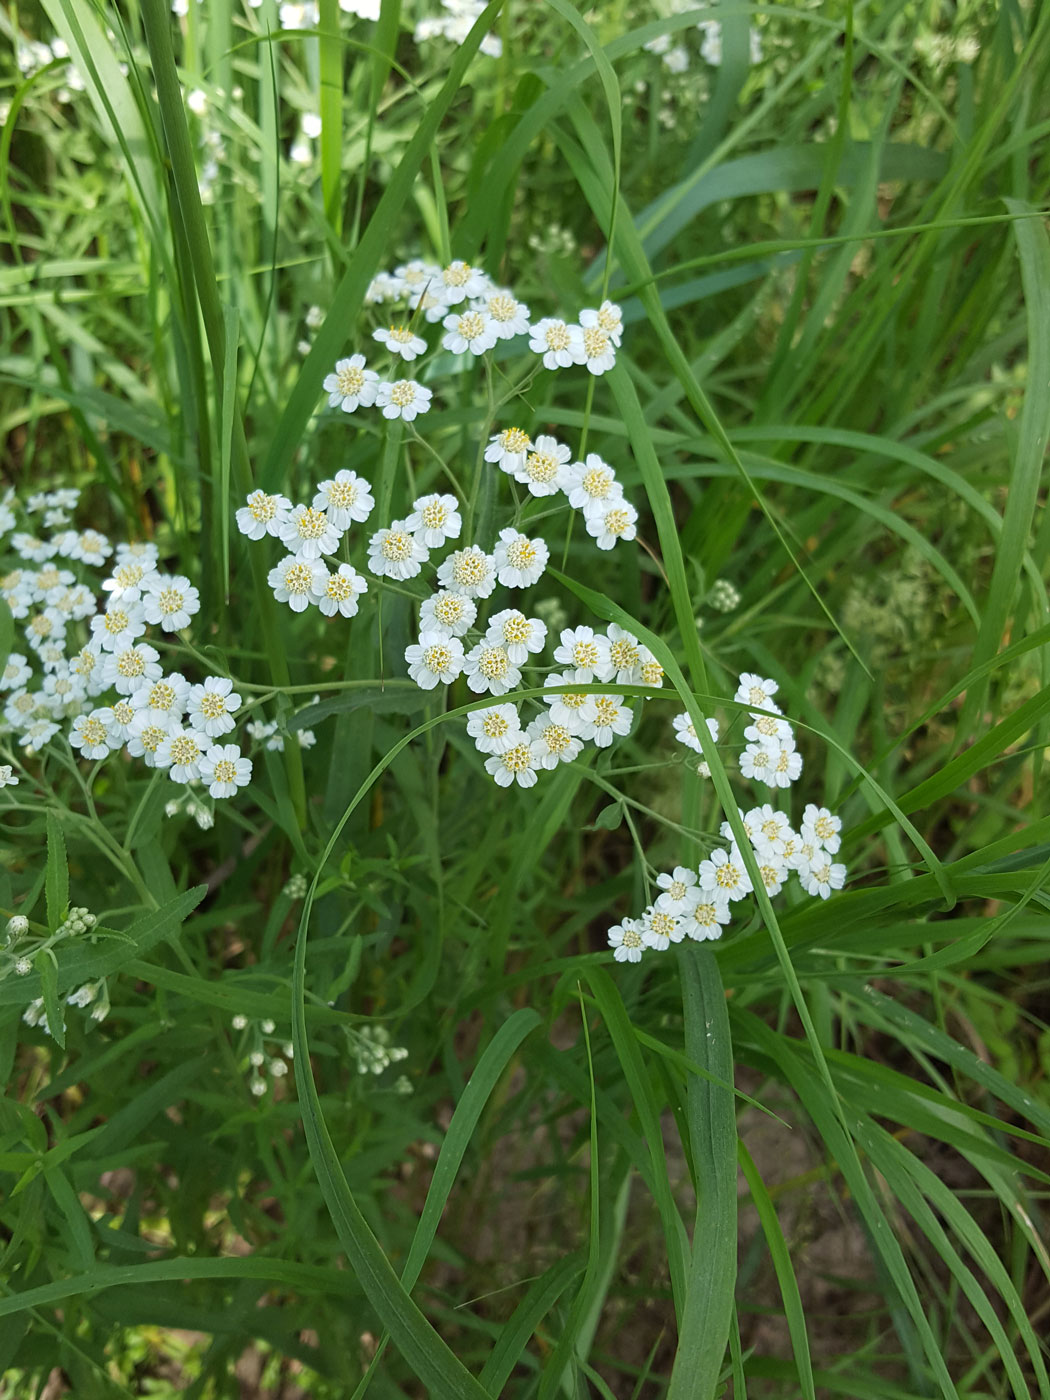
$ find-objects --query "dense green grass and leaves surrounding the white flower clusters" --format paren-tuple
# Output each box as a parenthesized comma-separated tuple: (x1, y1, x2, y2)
(0, 0, 1050, 1400)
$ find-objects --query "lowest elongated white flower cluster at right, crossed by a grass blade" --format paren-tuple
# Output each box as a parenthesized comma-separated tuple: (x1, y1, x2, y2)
(609, 804, 846, 962)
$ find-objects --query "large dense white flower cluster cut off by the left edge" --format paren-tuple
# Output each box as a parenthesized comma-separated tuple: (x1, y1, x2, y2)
(0, 490, 252, 798)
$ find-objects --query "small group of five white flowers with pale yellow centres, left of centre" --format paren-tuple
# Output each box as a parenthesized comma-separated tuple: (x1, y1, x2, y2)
(235, 470, 375, 617)
